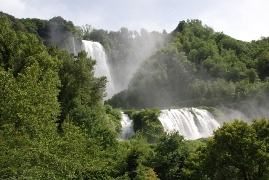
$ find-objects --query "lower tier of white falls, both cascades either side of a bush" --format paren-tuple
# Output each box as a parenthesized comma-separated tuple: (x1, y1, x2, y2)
(121, 108, 220, 140)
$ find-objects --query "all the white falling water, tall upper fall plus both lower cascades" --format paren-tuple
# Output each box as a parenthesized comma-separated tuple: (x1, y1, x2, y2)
(81, 40, 220, 140)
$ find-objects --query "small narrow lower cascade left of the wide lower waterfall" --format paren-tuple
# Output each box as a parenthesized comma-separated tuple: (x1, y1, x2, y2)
(120, 112, 135, 140)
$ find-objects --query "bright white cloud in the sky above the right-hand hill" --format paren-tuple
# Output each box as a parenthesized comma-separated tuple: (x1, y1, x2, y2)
(199, 0, 269, 41)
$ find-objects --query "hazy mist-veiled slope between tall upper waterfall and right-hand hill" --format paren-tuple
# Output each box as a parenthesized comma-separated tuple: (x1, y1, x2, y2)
(107, 28, 167, 93)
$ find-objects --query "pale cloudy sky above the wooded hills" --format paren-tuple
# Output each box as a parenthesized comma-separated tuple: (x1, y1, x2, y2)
(0, 0, 269, 41)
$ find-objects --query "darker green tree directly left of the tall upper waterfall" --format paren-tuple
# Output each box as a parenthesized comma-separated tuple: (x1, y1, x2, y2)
(48, 46, 107, 129)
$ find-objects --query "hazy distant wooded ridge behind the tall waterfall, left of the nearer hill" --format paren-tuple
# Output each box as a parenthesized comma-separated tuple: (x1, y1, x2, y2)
(0, 12, 168, 91)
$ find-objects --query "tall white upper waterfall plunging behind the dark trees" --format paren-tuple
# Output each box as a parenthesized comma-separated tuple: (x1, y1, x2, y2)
(82, 40, 115, 99)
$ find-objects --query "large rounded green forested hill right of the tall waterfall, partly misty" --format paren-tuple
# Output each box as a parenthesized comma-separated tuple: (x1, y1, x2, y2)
(107, 20, 269, 116)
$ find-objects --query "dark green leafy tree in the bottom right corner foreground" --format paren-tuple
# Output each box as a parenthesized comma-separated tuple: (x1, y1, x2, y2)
(183, 119, 269, 180)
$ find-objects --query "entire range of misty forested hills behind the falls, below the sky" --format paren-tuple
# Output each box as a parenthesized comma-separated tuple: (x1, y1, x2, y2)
(2, 9, 269, 116)
